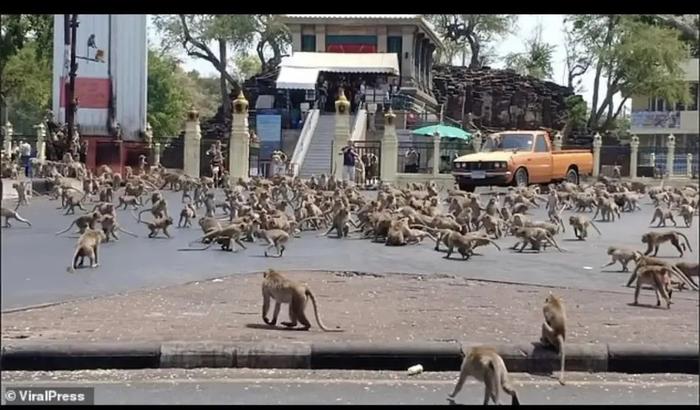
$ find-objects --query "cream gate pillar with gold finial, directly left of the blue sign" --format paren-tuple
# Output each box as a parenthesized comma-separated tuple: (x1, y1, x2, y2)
(228, 91, 250, 181)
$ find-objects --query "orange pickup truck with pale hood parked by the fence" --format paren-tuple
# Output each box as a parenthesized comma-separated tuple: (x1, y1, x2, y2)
(452, 131, 593, 192)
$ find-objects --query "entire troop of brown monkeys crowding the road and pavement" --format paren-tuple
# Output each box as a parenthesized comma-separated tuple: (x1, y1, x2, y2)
(2, 165, 699, 404)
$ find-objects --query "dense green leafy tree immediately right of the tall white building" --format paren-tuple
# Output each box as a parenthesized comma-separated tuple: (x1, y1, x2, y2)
(148, 50, 192, 140)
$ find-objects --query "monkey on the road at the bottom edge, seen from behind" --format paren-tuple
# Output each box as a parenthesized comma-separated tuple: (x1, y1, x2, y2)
(448, 346, 520, 406)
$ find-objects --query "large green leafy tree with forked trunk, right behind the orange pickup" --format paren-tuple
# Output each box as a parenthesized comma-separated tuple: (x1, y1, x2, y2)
(567, 15, 689, 130)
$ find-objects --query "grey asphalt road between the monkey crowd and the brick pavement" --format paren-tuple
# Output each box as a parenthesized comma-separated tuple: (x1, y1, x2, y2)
(1, 192, 698, 310)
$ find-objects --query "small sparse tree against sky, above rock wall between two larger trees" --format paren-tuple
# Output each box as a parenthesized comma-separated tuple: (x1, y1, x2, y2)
(505, 24, 556, 80)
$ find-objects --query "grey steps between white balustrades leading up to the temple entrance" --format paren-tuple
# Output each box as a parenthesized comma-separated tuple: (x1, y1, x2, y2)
(299, 114, 355, 178)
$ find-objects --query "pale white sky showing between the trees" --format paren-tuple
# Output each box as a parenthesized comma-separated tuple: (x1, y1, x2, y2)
(148, 14, 629, 111)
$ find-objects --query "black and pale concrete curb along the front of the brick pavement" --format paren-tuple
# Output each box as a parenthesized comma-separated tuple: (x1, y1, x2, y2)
(0, 342, 700, 374)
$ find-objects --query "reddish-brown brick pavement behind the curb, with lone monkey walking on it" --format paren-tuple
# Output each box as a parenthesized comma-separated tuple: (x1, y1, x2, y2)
(1, 272, 698, 346)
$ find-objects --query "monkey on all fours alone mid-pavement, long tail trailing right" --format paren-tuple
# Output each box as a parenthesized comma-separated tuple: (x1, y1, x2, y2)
(262, 270, 343, 332)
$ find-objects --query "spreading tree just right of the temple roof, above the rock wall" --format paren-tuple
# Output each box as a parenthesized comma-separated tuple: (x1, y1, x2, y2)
(427, 14, 518, 69)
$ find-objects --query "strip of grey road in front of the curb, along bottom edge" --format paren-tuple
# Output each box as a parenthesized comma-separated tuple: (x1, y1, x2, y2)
(2, 369, 698, 405)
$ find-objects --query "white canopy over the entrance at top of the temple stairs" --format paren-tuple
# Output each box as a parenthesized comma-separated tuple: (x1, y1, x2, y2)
(276, 52, 399, 90)
